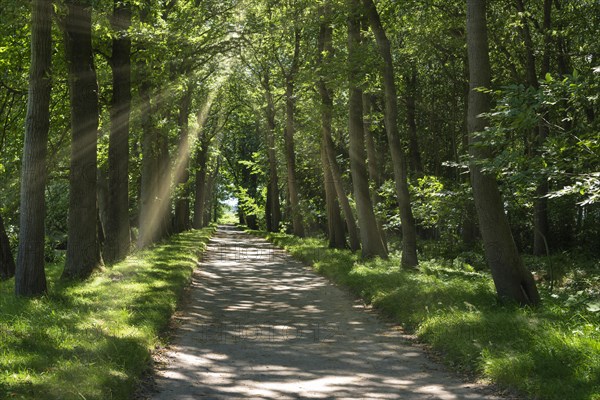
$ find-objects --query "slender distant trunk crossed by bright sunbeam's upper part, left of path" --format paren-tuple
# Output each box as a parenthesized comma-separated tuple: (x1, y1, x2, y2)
(173, 87, 192, 233)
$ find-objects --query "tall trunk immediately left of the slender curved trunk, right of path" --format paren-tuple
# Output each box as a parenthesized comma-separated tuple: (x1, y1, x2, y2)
(348, 0, 387, 258)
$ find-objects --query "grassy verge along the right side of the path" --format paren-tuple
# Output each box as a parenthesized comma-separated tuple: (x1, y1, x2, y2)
(250, 228, 600, 400)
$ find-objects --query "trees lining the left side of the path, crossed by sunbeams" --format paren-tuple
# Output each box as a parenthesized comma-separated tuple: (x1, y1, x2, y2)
(1, 0, 232, 296)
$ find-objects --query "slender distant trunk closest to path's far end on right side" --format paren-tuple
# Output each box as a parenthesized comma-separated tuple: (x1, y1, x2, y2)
(263, 75, 281, 232)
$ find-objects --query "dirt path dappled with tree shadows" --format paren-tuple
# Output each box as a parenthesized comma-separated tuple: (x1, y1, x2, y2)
(153, 227, 497, 400)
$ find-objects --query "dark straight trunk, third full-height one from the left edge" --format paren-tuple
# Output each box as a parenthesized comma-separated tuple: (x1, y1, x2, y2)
(103, 0, 131, 263)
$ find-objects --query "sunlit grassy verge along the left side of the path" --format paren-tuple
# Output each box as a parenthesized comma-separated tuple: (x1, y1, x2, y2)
(0, 227, 214, 400)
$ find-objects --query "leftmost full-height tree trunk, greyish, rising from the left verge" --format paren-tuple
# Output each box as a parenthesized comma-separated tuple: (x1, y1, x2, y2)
(15, 0, 52, 296)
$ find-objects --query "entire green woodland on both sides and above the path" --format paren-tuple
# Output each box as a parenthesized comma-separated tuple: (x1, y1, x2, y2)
(0, 0, 600, 305)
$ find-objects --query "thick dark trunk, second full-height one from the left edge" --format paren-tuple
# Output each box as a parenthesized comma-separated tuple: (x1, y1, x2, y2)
(62, 1, 102, 279)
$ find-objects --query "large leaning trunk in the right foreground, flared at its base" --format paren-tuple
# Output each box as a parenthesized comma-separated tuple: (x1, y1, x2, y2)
(467, 0, 540, 305)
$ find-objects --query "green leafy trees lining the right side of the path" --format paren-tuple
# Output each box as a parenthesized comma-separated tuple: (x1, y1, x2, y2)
(226, 0, 600, 304)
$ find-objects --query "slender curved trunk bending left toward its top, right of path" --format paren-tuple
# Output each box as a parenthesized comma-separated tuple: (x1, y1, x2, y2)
(363, 0, 418, 268)
